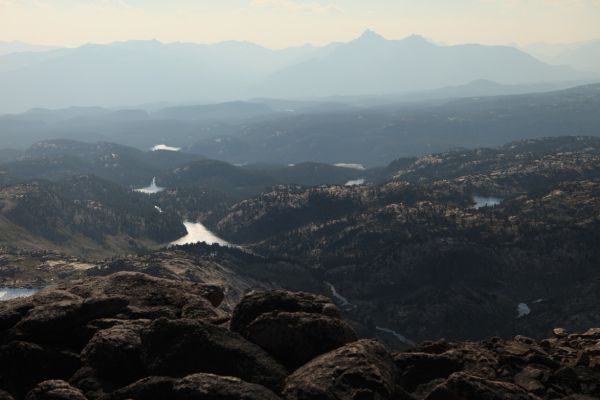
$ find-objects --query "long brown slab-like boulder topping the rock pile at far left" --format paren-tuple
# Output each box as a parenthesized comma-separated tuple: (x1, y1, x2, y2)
(0, 272, 228, 351)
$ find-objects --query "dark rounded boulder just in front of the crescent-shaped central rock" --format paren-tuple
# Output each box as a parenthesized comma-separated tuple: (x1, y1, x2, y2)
(244, 312, 357, 371)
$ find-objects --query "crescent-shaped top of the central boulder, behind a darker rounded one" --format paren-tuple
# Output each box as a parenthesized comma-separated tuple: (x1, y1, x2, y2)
(230, 290, 340, 335)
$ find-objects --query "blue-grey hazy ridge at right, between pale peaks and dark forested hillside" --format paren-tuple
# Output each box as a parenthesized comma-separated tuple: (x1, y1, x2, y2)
(188, 83, 600, 166)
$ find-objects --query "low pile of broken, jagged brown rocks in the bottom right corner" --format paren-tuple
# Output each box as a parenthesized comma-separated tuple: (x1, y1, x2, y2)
(393, 329, 600, 400)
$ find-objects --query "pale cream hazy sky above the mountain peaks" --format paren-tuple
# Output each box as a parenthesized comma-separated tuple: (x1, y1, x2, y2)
(0, 0, 600, 48)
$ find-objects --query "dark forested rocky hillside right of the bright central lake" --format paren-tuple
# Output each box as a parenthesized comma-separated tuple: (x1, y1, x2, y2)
(205, 137, 600, 341)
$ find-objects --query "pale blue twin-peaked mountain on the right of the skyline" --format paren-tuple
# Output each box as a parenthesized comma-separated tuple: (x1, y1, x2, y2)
(260, 31, 587, 97)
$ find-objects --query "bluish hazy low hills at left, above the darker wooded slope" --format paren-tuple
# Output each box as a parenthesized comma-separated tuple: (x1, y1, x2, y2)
(0, 139, 370, 199)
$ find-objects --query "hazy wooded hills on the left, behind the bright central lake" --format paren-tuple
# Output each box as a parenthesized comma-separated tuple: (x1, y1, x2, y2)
(0, 140, 366, 255)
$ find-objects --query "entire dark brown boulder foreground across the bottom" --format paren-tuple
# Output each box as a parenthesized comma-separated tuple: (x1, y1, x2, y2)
(0, 272, 600, 400)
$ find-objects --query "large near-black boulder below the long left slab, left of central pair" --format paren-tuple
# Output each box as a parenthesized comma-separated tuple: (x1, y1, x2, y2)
(142, 318, 287, 389)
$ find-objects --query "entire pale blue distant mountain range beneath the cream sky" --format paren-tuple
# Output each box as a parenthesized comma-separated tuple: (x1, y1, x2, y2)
(0, 31, 595, 112)
